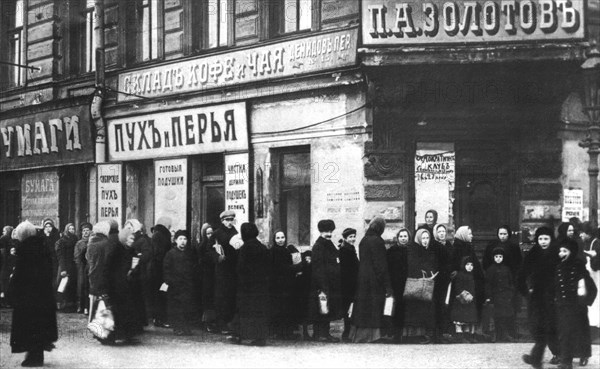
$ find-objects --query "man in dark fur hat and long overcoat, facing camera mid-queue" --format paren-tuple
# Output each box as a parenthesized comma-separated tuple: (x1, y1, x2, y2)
(309, 219, 343, 342)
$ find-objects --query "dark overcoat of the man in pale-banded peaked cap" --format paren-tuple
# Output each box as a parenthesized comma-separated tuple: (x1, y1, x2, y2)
(210, 225, 238, 323)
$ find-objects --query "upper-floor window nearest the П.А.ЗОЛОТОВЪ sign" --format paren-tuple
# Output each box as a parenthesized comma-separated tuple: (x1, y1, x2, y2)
(269, 0, 320, 36)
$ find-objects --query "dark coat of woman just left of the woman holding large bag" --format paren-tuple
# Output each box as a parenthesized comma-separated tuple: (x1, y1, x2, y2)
(387, 244, 409, 329)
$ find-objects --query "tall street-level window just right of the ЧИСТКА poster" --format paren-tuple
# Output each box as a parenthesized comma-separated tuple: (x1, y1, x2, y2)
(279, 148, 312, 246)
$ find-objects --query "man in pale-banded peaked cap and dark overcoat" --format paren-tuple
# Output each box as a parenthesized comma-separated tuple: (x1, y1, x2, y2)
(210, 210, 238, 334)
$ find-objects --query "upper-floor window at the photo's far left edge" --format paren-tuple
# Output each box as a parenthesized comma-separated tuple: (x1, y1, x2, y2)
(0, 0, 27, 89)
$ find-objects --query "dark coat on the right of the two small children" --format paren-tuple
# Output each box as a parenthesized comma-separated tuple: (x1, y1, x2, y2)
(485, 261, 515, 318)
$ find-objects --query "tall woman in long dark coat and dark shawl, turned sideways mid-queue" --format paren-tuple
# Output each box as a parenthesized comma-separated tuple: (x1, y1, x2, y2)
(351, 217, 392, 342)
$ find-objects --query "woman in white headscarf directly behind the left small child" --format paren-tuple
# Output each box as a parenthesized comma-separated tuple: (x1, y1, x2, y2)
(452, 226, 485, 322)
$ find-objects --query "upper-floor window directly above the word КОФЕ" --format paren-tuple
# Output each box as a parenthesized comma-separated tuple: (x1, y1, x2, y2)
(191, 0, 235, 51)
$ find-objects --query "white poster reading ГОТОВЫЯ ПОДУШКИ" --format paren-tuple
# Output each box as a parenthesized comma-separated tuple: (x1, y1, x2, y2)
(154, 158, 188, 232)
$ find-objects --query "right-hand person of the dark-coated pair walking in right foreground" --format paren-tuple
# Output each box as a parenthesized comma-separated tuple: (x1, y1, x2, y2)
(554, 239, 597, 369)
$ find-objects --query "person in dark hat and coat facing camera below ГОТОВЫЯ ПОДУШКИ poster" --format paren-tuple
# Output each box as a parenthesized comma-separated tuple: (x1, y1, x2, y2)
(163, 230, 199, 336)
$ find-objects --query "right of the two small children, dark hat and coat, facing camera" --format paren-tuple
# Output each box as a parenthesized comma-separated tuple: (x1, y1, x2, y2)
(485, 247, 515, 342)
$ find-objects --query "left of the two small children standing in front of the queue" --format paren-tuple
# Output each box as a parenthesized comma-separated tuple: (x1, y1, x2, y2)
(451, 256, 477, 343)
